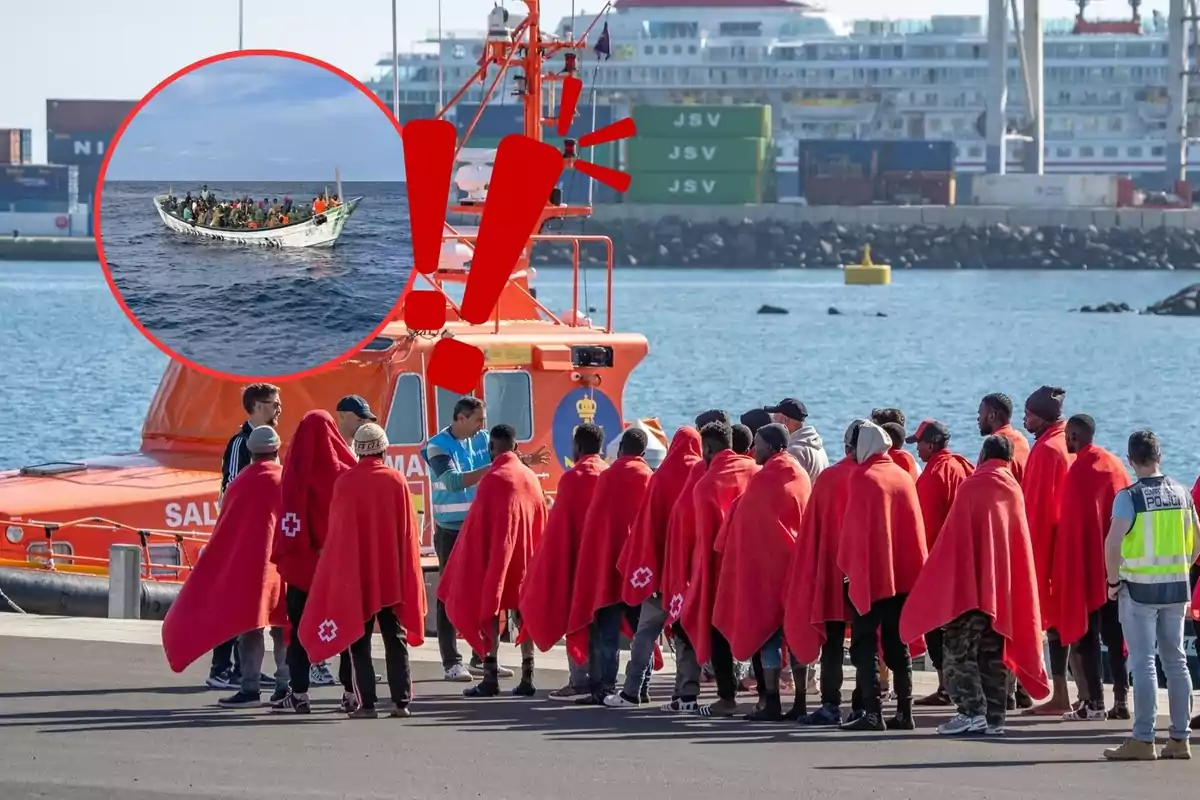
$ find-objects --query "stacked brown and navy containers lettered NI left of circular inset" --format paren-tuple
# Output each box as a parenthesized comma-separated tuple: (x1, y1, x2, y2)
(46, 100, 137, 205)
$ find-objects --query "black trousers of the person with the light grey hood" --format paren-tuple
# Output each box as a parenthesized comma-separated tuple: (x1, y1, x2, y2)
(850, 595, 912, 714)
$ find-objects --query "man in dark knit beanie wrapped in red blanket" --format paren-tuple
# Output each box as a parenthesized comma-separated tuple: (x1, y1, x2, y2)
(1021, 386, 1075, 716)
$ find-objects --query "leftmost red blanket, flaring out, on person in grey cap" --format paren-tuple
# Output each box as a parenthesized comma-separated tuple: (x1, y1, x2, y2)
(162, 461, 287, 672)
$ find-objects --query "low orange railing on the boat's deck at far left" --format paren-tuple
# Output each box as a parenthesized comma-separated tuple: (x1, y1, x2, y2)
(0, 517, 210, 582)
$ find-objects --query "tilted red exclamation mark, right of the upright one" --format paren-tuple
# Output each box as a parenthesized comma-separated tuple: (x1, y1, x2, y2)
(427, 134, 563, 393)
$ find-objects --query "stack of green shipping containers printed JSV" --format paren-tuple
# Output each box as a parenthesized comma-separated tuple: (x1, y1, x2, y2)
(625, 106, 774, 205)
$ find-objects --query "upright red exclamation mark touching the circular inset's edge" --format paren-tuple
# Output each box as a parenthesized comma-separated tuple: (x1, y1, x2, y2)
(401, 120, 457, 331)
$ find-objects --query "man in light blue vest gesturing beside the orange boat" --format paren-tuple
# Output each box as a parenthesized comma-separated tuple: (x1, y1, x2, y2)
(421, 396, 550, 682)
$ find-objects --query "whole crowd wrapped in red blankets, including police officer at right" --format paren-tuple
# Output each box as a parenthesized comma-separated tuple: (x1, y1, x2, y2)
(163, 386, 1200, 760)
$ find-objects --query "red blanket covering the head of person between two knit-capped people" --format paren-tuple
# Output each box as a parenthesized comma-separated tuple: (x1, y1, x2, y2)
(271, 409, 356, 591)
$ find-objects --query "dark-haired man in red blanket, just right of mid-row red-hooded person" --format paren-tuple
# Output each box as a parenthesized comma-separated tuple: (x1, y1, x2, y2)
(674, 422, 758, 716)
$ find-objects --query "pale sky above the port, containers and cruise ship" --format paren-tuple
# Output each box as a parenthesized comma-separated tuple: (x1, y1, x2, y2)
(0, 0, 1166, 161)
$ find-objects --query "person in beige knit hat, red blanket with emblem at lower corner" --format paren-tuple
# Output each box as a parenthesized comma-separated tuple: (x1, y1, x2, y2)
(300, 422, 426, 720)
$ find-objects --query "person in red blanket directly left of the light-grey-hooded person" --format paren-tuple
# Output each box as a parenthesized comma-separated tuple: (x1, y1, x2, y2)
(784, 420, 866, 726)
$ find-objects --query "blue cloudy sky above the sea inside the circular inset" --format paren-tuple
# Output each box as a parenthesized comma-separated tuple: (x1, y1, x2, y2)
(106, 55, 404, 182)
